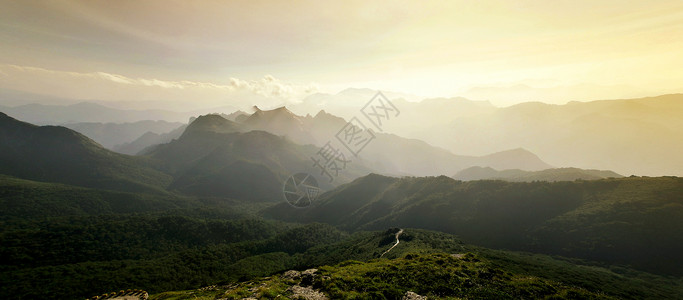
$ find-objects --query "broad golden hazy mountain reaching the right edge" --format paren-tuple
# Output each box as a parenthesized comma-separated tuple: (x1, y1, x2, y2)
(420, 94, 683, 175)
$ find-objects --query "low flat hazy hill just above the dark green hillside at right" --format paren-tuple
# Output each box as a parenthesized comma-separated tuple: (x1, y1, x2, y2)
(453, 167, 623, 182)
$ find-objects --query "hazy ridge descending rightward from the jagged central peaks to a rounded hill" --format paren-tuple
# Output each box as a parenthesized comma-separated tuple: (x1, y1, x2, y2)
(227, 107, 551, 176)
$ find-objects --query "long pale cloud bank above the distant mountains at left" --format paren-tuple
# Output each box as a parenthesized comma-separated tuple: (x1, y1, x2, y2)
(0, 64, 318, 107)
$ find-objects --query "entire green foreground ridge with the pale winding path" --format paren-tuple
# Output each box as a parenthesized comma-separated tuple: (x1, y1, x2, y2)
(151, 229, 683, 300)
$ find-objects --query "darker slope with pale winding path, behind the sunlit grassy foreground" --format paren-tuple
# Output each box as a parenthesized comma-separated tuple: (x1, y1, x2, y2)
(302, 228, 683, 299)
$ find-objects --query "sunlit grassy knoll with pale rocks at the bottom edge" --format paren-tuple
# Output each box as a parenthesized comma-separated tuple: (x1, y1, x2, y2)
(150, 253, 613, 300)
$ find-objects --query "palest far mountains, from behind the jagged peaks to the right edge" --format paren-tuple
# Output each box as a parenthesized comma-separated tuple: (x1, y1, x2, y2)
(292, 89, 683, 176)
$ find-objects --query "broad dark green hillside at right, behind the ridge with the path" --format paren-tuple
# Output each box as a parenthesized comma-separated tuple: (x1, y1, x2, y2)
(263, 175, 683, 276)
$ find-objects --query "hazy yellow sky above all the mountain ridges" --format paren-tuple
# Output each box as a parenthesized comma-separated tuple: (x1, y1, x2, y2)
(0, 0, 683, 110)
